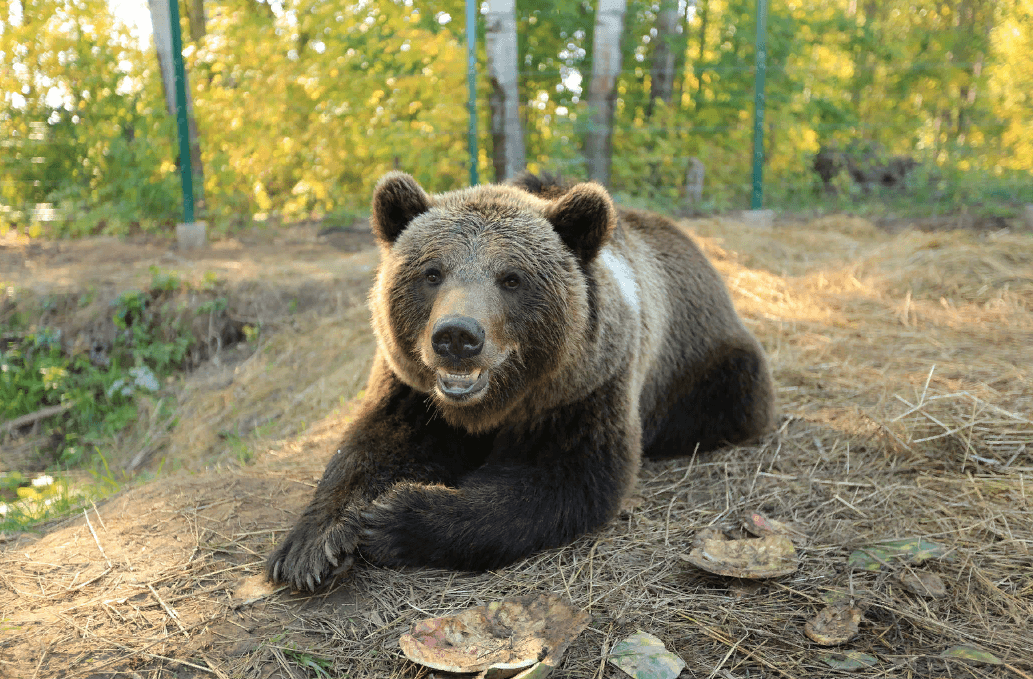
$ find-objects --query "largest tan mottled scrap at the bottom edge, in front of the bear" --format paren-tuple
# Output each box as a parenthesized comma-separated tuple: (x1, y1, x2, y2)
(399, 594, 590, 679)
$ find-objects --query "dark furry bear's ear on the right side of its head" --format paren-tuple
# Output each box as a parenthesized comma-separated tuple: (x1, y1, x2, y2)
(544, 182, 617, 265)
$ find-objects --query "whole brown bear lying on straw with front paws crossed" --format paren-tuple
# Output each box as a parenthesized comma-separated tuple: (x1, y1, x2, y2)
(268, 173, 774, 590)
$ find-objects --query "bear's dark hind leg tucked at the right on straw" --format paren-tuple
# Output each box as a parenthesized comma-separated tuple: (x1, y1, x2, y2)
(643, 342, 775, 459)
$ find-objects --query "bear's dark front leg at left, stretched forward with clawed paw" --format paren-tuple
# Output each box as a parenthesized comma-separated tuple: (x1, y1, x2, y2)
(267, 360, 490, 590)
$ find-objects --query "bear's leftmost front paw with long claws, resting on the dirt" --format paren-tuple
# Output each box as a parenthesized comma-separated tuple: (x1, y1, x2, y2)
(265, 510, 356, 591)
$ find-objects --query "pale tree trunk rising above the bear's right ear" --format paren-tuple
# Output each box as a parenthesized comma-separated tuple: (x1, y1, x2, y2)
(585, 0, 626, 186)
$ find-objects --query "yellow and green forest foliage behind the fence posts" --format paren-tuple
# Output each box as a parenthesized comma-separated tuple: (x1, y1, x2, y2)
(0, 0, 1033, 236)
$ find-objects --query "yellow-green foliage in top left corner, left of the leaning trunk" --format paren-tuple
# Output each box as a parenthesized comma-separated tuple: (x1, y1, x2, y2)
(0, 0, 179, 230)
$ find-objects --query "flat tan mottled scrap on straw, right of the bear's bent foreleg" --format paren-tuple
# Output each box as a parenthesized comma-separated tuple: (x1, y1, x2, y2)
(681, 534, 797, 580)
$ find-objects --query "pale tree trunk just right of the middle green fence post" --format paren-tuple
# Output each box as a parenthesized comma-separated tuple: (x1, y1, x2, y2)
(487, 0, 526, 182)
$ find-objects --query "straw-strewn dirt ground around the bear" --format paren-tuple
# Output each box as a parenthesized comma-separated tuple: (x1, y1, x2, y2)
(0, 212, 1033, 679)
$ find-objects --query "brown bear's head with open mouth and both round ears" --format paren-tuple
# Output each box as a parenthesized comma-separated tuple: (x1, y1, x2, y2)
(370, 173, 617, 432)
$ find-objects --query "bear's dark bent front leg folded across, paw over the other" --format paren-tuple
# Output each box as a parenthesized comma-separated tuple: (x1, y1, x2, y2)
(359, 383, 640, 570)
